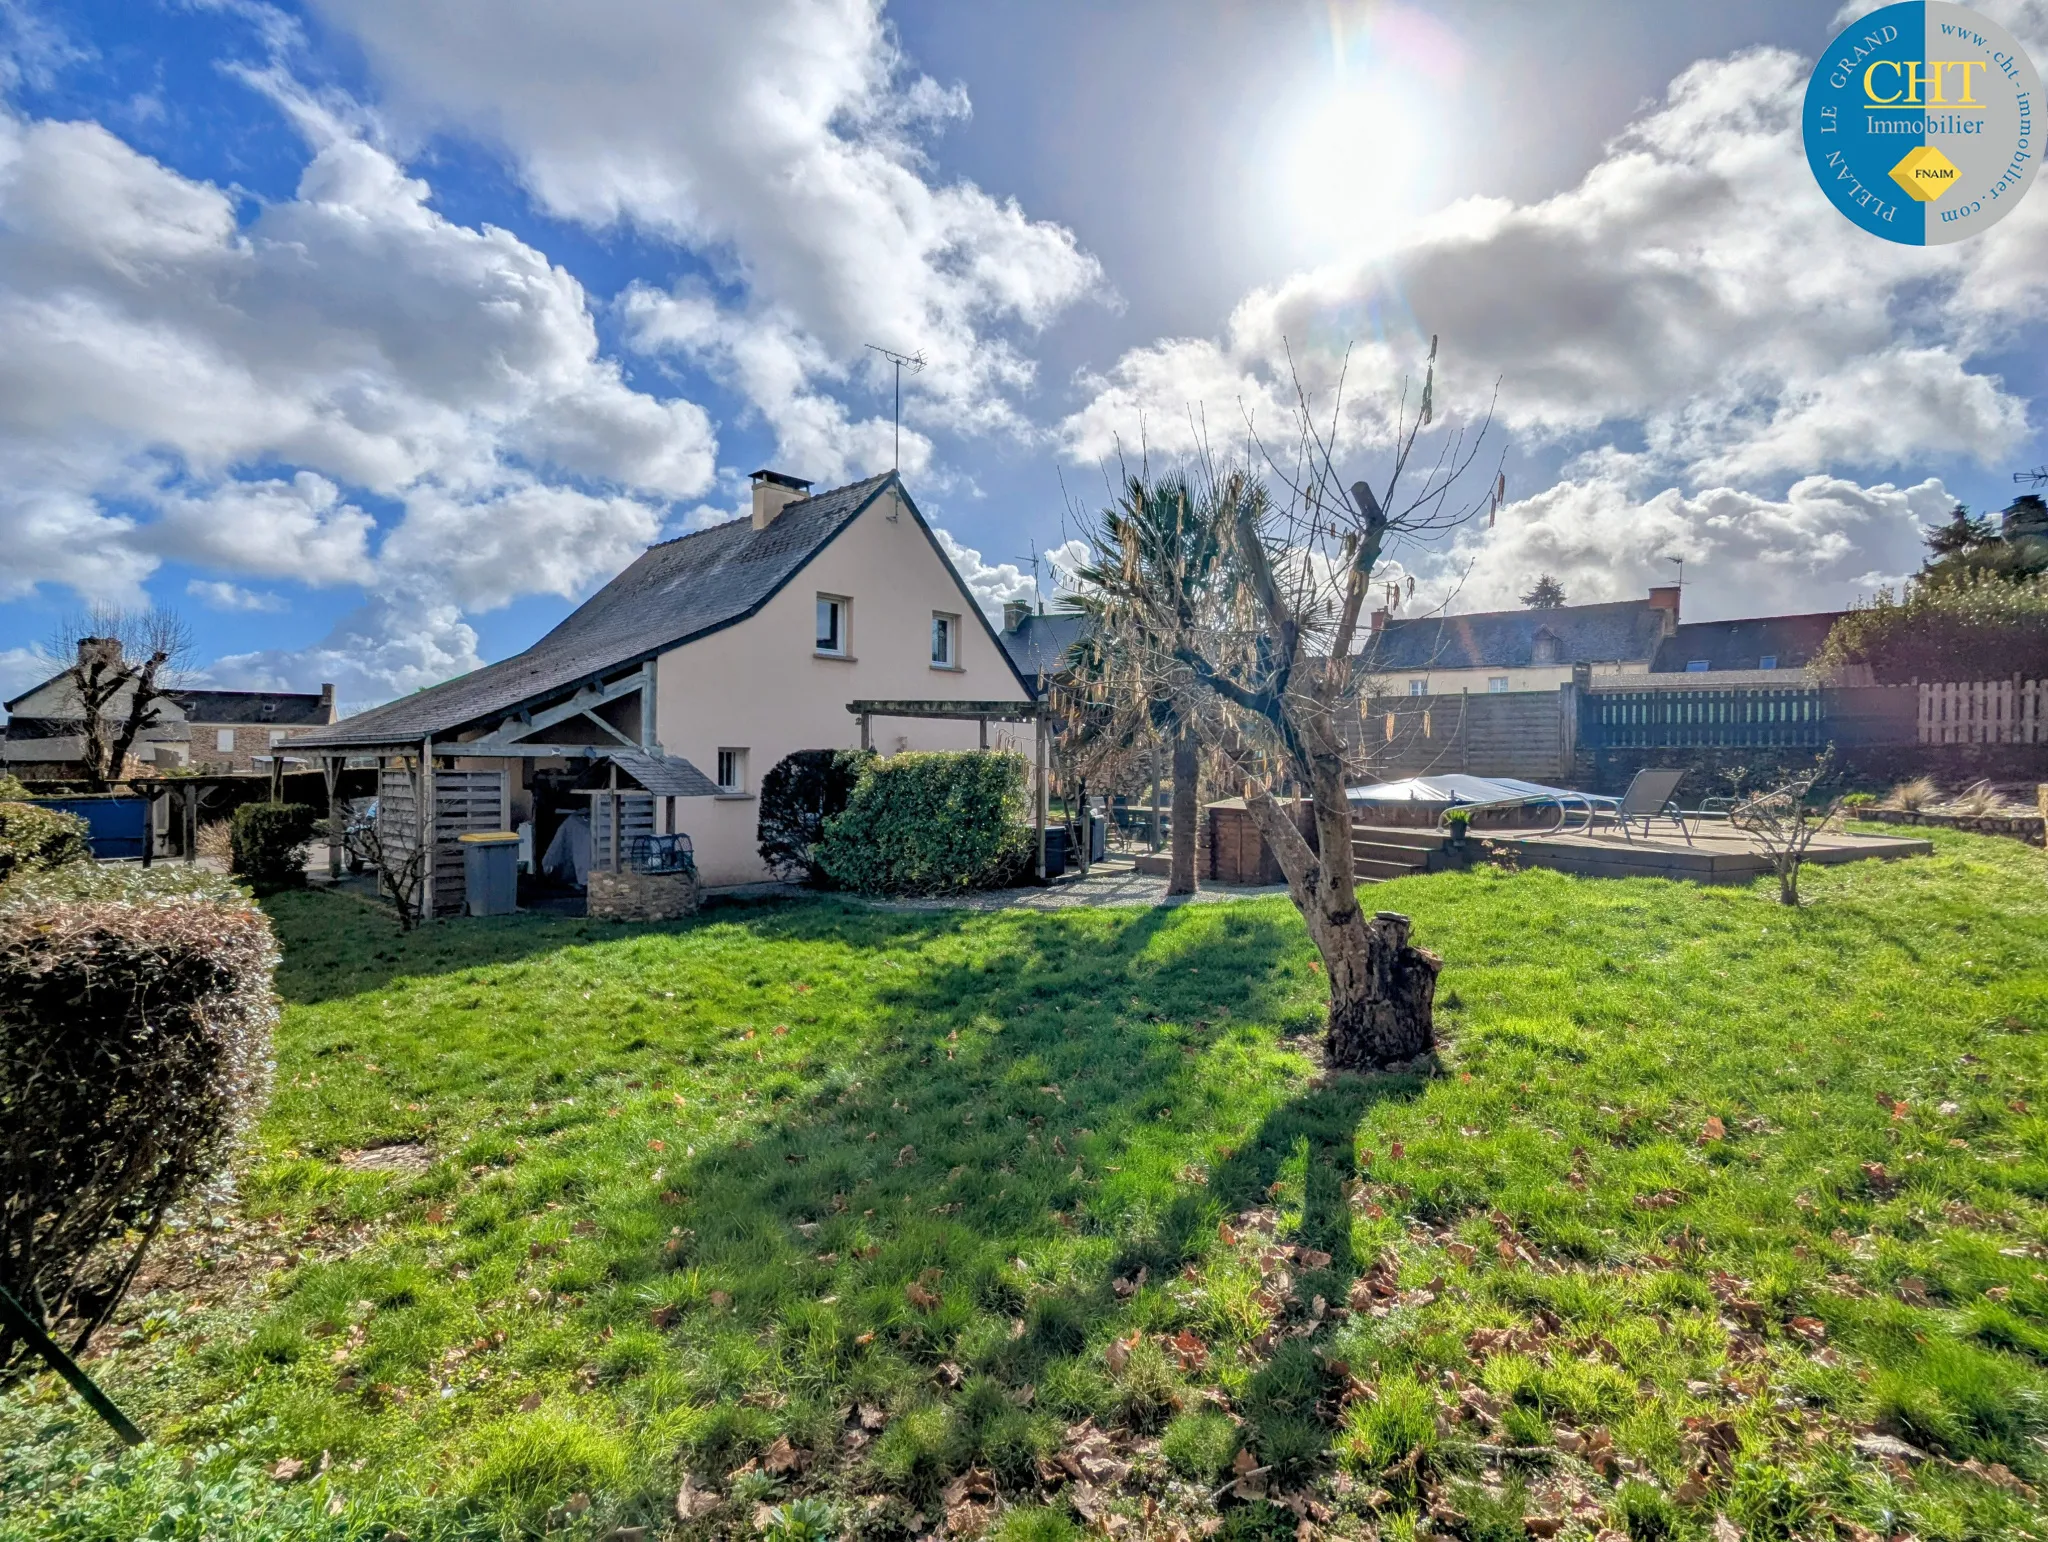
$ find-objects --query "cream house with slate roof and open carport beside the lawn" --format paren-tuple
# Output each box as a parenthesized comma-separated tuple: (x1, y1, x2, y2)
(293, 471, 1030, 885)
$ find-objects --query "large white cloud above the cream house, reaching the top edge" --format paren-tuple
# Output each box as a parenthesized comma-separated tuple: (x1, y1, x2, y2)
(315, 0, 1104, 462)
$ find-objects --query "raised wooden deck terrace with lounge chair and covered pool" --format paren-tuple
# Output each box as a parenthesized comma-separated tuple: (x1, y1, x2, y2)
(1352, 821, 1933, 883)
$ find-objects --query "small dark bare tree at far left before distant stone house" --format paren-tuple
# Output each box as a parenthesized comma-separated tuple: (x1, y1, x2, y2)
(45, 606, 193, 793)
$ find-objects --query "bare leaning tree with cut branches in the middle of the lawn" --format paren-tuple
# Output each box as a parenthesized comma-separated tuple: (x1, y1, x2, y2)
(1102, 342, 1501, 1067)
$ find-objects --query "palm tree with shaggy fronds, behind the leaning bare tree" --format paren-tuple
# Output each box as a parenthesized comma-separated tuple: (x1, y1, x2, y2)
(1069, 475, 1225, 895)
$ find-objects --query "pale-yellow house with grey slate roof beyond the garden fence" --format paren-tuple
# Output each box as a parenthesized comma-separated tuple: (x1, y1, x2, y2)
(1362, 584, 1679, 696)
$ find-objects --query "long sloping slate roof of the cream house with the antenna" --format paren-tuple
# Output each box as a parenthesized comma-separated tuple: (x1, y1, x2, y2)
(293, 471, 1015, 749)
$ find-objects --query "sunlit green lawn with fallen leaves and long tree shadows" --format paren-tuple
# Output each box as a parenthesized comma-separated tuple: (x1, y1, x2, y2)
(0, 833, 2048, 1542)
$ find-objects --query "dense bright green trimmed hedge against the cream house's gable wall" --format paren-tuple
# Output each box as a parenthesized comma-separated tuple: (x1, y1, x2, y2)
(817, 752, 1032, 895)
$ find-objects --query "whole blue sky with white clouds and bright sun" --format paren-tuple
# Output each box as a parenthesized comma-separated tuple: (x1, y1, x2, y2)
(0, 0, 2048, 704)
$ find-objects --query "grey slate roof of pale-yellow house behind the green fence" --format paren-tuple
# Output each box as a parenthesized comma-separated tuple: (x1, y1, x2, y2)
(1366, 600, 1669, 672)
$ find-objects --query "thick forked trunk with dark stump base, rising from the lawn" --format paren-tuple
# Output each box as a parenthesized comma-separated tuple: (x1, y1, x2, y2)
(1247, 729, 1444, 1069)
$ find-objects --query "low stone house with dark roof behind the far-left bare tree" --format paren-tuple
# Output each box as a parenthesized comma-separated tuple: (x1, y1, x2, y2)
(0, 655, 334, 782)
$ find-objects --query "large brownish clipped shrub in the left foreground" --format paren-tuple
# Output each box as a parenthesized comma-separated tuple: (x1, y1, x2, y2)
(0, 864, 279, 1378)
